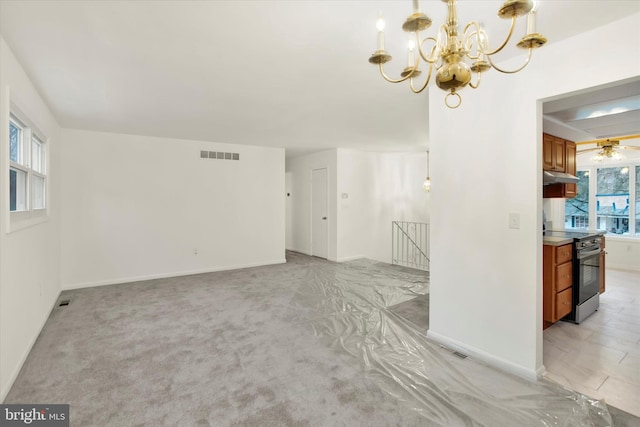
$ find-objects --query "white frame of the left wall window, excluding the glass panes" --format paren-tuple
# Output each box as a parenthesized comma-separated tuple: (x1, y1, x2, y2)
(2, 102, 50, 234)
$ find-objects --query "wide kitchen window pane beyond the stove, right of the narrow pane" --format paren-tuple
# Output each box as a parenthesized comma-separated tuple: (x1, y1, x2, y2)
(596, 166, 629, 234)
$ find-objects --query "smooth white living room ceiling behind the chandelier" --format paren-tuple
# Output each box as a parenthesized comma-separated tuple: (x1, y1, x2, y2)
(0, 0, 640, 156)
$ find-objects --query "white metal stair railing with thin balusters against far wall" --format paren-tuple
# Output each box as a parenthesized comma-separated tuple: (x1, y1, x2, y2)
(391, 221, 429, 271)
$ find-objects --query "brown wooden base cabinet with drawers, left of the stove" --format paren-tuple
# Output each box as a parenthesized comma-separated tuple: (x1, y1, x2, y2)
(542, 244, 573, 329)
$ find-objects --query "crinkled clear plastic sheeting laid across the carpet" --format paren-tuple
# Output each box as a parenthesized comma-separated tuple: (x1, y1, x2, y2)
(290, 254, 612, 427)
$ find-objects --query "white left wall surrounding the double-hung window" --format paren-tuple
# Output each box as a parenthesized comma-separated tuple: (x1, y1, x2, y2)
(0, 37, 60, 401)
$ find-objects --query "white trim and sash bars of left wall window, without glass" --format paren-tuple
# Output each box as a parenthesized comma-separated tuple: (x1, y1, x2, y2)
(5, 98, 51, 234)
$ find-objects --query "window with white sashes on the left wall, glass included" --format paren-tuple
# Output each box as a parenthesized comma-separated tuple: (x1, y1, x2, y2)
(9, 112, 47, 216)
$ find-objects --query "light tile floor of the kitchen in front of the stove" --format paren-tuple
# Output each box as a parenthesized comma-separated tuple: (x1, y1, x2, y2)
(544, 269, 640, 416)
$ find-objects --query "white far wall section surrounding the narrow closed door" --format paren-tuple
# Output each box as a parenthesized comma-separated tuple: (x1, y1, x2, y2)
(286, 149, 338, 261)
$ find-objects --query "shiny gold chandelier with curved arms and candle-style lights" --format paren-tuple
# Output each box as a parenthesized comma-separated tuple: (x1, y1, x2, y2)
(369, 0, 547, 108)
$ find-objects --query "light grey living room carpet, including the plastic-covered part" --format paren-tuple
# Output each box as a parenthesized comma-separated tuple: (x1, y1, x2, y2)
(5, 253, 624, 427)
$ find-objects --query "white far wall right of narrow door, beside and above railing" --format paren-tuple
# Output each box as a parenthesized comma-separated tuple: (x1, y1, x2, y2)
(337, 149, 429, 262)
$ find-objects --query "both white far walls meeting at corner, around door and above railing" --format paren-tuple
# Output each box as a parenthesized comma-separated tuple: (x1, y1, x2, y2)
(287, 148, 429, 262)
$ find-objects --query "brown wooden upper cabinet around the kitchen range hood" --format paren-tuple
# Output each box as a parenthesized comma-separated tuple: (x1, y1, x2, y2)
(542, 133, 578, 199)
